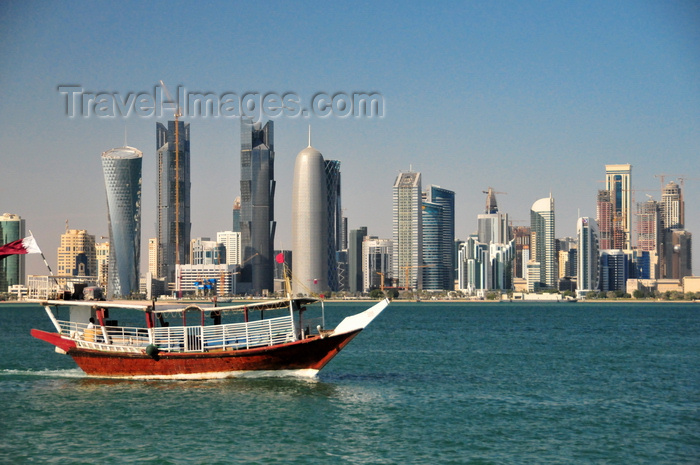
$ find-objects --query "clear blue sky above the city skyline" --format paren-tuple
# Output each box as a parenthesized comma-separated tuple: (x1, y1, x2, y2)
(0, 0, 700, 274)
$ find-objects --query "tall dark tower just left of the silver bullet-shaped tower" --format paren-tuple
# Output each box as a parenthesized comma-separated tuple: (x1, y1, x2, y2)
(239, 118, 274, 294)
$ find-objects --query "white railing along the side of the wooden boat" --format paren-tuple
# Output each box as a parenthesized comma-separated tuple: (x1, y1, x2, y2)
(58, 315, 296, 353)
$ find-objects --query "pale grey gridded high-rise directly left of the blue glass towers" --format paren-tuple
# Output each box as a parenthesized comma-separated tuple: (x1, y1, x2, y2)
(392, 171, 423, 289)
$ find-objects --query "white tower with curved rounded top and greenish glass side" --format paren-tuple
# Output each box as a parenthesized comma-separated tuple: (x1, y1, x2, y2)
(530, 194, 557, 289)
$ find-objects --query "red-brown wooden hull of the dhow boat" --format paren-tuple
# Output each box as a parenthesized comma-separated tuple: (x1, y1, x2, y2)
(32, 329, 361, 379)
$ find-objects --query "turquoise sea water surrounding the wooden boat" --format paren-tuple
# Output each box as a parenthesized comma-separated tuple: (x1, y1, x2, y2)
(0, 303, 700, 464)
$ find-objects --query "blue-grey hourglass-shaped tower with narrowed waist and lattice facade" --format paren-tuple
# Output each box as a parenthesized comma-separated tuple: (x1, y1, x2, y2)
(102, 147, 143, 299)
